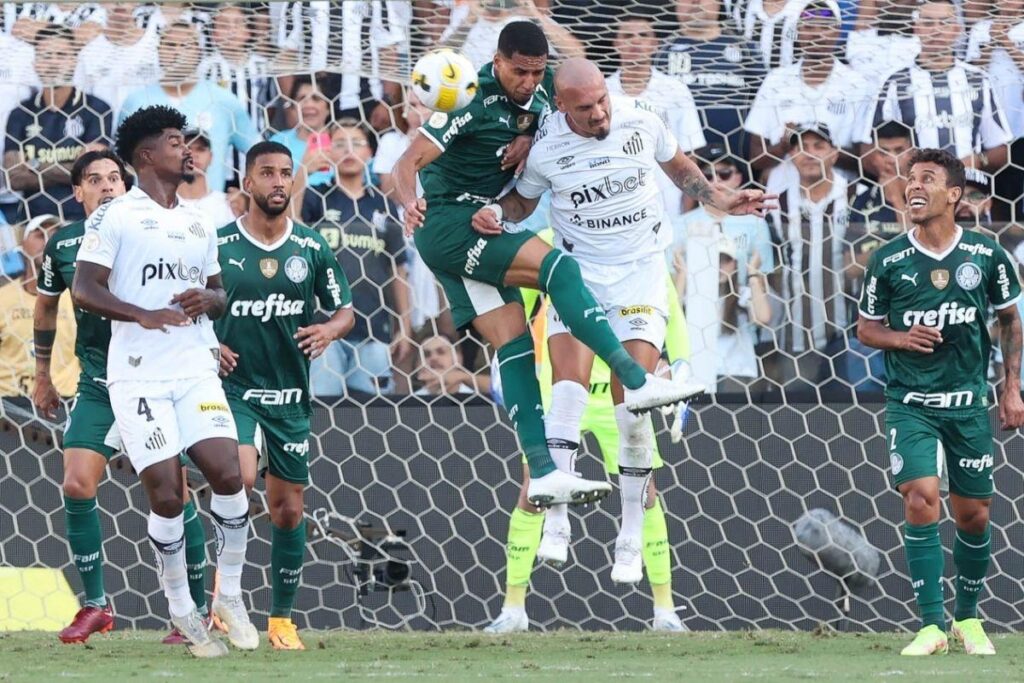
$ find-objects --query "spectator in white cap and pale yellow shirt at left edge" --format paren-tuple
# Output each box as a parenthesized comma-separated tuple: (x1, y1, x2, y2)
(0, 215, 79, 397)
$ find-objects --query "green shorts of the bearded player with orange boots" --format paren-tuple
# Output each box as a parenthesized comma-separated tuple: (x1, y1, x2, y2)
(227, 395, 309, 484)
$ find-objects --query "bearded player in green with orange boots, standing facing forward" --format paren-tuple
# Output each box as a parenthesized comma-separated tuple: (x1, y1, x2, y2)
(215, 142, 354, 650)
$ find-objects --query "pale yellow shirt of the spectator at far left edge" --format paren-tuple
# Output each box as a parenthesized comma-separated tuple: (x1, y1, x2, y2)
(0, 281, 79, 397)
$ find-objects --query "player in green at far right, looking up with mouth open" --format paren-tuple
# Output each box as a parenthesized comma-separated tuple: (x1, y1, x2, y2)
(857, 150, 1024, 655)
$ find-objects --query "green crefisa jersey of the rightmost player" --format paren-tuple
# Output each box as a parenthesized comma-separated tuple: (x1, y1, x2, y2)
(860, 228, 1021, 409)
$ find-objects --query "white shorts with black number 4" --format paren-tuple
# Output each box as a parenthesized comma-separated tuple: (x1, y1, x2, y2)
(110, 375, 238, 472)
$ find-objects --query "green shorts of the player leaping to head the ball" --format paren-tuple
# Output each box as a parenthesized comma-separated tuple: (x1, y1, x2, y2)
(416, 200, 535, 328)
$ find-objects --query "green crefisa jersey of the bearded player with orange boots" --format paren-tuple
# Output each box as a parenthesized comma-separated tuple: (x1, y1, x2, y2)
(214, 221, 352, 418)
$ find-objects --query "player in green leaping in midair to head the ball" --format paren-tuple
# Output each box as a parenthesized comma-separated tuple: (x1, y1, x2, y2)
(393, 22, 724, 506)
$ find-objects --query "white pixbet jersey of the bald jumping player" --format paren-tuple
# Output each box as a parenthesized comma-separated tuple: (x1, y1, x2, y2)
(516, 95, 679, 263)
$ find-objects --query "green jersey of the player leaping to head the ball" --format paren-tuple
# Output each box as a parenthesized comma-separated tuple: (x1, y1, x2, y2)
(420, 63, 555, 202)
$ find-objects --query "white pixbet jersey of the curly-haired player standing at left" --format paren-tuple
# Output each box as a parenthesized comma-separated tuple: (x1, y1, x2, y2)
(78, 186, 220, 384)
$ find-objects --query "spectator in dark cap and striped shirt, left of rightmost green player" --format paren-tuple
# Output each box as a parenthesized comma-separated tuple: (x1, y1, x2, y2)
(766, 123, 856, 386)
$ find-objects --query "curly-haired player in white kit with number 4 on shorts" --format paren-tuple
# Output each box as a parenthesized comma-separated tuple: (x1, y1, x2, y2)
(72, 106, 259, 656)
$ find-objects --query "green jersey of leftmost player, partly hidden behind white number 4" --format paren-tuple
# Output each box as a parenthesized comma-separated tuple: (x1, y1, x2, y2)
(37, 220, 111, 379)
